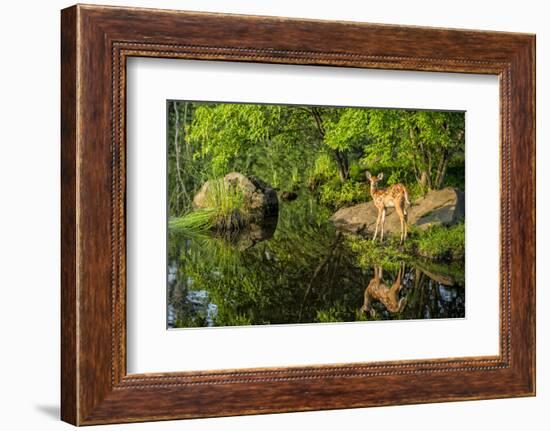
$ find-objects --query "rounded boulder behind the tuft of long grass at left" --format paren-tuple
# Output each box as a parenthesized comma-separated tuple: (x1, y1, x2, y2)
(193, 172, 279, 223)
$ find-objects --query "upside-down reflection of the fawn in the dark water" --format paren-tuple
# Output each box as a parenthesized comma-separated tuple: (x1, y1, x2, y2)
(361, 264, 407, 315)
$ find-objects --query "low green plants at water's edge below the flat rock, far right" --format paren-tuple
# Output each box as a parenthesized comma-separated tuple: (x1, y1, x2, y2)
(417, 223, 466, 260)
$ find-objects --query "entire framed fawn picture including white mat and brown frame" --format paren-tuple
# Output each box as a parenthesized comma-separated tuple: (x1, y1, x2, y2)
(61, 5, 535, 425)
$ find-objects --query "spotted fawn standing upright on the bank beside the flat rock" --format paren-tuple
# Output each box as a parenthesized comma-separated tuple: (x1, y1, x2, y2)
(366, 171, 411, 244)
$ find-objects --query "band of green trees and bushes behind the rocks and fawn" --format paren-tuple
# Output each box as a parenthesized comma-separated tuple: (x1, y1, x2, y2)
(167, 102, 464, 217)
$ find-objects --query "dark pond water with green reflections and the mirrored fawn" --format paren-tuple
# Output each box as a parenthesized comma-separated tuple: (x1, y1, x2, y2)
(167, 198, 465, 328)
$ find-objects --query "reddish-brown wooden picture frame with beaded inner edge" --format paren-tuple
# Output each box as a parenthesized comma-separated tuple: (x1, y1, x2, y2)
(61, 5, 535, 425)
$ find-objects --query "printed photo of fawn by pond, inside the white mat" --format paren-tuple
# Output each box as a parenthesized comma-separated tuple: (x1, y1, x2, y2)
(167, 100, 466, 328)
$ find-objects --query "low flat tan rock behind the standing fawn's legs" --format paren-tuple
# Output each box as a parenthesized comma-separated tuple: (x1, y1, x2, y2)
(330, 187, 464, 235)
